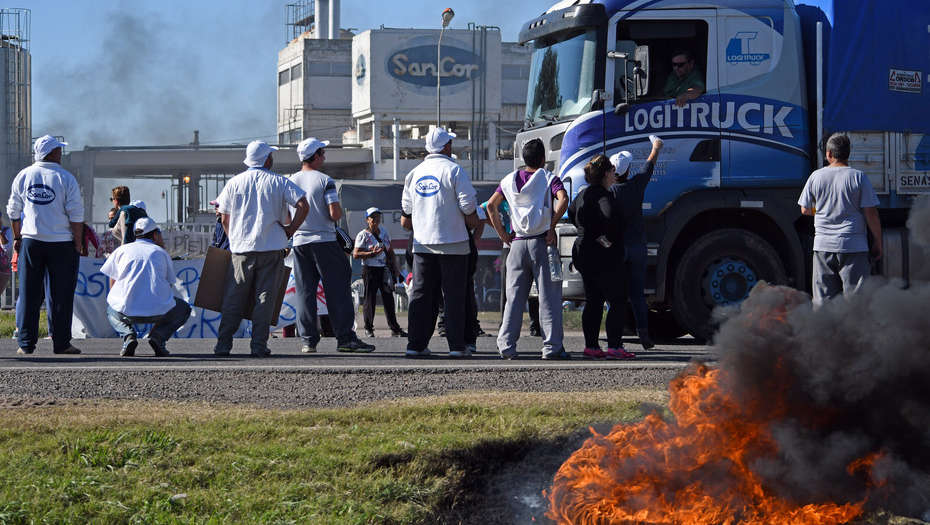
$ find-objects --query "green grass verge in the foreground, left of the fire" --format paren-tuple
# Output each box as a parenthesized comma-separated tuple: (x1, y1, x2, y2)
(0, 390, 665, 524)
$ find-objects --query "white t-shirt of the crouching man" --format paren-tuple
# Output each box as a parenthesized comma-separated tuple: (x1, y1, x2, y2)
(100, 239, 176, 317)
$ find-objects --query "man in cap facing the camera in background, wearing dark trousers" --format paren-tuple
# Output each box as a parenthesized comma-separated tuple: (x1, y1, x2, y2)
(352, 207, 407, 337)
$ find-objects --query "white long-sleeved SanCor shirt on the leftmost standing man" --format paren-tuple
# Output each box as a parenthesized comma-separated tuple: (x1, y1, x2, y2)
(6, 161, 84, 242)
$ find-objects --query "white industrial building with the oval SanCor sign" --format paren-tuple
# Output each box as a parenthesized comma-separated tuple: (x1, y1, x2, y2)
(277, 0, 531, 180)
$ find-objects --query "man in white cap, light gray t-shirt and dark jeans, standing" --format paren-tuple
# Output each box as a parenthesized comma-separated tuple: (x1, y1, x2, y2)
(291, 137, 375, 354)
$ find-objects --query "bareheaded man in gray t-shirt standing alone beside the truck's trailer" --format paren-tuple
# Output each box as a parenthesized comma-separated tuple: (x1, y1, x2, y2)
(798, 133, 882, 305)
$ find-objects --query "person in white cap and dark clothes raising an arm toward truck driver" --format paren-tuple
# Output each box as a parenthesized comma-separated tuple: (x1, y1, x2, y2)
(610, 135, 663, 350)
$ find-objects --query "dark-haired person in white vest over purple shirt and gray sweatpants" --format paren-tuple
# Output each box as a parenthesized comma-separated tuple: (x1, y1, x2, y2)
(488, 139, 571, 359)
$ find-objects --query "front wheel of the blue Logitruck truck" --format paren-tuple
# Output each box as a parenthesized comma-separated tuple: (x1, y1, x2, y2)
(672, 228, 788, 340)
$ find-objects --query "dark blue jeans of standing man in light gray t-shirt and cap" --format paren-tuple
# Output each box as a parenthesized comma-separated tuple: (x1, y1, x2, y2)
(294, 241, 356, 346)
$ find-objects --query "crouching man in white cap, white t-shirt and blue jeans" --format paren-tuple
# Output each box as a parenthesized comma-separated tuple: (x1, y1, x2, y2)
(100, 217, 191, 357)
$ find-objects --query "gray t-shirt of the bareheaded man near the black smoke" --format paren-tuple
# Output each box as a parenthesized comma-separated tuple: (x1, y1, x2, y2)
(798, 167, 878, 253)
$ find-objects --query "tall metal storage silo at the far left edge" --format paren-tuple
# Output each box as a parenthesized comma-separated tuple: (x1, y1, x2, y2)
(0, 8, 32, 209)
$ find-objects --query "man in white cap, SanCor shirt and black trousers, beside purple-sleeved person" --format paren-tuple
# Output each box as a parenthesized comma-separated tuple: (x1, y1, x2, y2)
(401, 128, 478, 357)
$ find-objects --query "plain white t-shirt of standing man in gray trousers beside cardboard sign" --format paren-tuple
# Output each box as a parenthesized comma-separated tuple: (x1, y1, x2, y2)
(216, 168, 304, 253)
